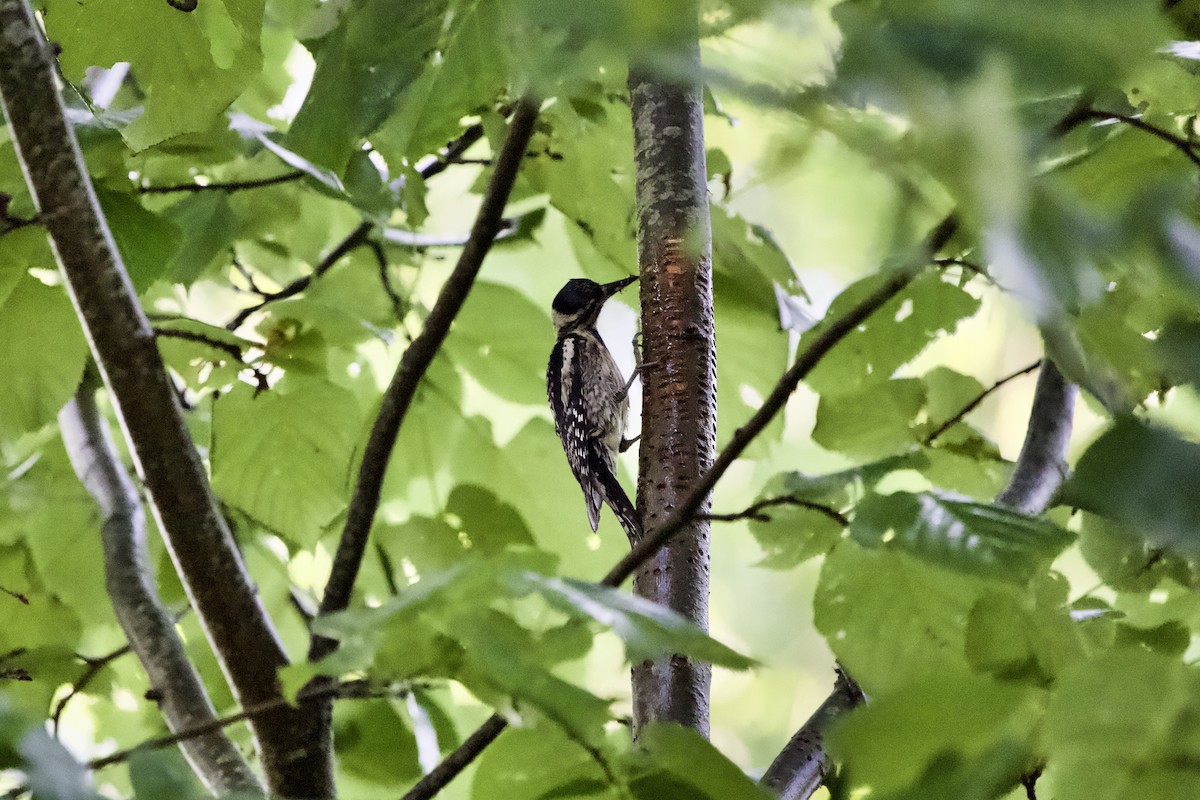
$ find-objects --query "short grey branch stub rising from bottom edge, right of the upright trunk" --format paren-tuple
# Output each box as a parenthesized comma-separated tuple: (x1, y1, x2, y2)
(760, 667, 866, 800)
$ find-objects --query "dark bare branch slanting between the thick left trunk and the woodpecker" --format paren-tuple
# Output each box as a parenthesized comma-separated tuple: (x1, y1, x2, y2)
(308, 100, 539, 660)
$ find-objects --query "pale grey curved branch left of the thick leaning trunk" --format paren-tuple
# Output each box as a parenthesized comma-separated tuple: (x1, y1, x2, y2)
(54, 368, 264, 796)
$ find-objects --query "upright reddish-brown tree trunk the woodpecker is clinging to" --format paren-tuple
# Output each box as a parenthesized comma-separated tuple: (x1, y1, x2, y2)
(629, 47, 716, 735)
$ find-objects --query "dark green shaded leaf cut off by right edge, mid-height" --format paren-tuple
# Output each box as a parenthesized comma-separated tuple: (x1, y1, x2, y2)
(1062, 417, 1200, 558)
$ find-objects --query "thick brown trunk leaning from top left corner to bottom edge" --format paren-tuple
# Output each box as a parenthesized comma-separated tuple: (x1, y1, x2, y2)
(0, 0, 334, 799)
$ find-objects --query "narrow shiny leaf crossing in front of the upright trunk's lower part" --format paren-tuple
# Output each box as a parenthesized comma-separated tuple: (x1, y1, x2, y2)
(509, 572, 755, 669)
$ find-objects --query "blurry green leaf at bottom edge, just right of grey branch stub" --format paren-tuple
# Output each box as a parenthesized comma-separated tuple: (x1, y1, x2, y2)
(827, 676, 1039, 800)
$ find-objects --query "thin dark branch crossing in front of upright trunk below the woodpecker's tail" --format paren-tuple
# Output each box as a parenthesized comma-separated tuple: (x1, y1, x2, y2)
(403, 215, 959, 800)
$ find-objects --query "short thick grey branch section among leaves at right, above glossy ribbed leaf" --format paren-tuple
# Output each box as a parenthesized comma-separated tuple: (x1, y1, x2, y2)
(996, 359, 1079, 515)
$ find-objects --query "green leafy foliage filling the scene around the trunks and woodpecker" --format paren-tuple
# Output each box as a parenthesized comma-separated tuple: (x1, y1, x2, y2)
(7, 0, 1200, 800)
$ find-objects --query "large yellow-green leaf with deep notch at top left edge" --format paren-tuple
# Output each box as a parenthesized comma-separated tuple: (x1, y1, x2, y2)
(44, 0, 263, 151)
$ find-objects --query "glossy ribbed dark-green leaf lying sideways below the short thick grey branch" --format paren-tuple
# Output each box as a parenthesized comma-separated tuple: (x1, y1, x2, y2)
(850, 492, 1073, 582)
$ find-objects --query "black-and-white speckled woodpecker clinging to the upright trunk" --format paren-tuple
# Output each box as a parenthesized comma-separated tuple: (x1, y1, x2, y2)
(546, 277, 642, 541)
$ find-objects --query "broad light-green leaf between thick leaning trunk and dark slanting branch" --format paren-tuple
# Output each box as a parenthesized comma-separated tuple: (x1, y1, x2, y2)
(212, 375, 362, 543)
